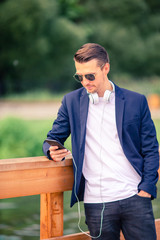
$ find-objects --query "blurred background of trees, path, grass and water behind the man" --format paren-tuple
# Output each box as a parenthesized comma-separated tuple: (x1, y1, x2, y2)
(0, 0, 160, 240)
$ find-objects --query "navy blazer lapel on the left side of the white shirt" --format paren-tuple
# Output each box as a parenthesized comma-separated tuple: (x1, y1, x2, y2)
(80, 89, 89, 150)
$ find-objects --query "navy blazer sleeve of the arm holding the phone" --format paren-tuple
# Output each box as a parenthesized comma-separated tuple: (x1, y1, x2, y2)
(43, 96, 70, 159)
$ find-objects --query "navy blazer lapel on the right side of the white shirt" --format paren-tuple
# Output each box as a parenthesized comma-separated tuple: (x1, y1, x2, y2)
(115, 85, 124, 148)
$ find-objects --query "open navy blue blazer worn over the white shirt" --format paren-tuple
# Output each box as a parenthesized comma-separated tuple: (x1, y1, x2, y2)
(43, 85, 159, 206)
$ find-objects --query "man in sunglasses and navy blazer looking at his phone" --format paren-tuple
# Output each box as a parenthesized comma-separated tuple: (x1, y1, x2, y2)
(43, 43, 159, 240)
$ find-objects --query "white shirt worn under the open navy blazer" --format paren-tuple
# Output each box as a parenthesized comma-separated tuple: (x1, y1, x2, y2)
(83, 86, 141, 203)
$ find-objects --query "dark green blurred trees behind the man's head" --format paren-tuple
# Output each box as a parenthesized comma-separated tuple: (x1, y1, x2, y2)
(0, 0, 160, 95)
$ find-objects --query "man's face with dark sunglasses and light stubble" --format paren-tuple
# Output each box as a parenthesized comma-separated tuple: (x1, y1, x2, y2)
(75, 59, 109, 97)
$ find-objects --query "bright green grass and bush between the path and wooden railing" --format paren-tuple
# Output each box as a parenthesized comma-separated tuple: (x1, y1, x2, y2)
(0, 118, 71, 159)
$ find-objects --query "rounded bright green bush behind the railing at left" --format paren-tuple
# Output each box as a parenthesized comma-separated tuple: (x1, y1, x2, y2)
(0, 118, 43, 159)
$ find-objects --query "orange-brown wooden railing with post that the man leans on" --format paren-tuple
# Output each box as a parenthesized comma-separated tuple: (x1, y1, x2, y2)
(0, 157, 160, 240)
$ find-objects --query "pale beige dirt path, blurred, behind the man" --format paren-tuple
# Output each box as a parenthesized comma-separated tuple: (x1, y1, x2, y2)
(0, 101, 160, 119)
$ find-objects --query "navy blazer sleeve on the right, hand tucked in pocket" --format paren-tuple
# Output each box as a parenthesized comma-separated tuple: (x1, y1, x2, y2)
(138, 96, 159, 199)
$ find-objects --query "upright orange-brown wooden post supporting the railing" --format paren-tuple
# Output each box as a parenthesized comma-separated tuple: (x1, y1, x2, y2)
(40, 192, 63, 240)
